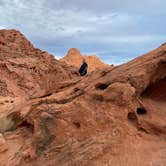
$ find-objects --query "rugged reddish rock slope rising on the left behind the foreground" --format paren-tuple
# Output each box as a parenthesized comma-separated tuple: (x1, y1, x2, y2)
(0, 30, 77, 98)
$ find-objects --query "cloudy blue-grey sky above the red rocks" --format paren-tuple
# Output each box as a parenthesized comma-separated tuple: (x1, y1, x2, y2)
(0, 0, 166, 64)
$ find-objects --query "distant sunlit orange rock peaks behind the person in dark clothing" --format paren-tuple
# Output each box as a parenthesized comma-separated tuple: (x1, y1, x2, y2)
(60, 48, 113, 72)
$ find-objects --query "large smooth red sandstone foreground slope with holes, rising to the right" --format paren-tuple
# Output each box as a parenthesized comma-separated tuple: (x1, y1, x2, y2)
(0, 29, 166, 166)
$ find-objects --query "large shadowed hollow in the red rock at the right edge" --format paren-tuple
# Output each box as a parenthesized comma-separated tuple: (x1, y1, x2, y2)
(138, 62, 166, 114)
